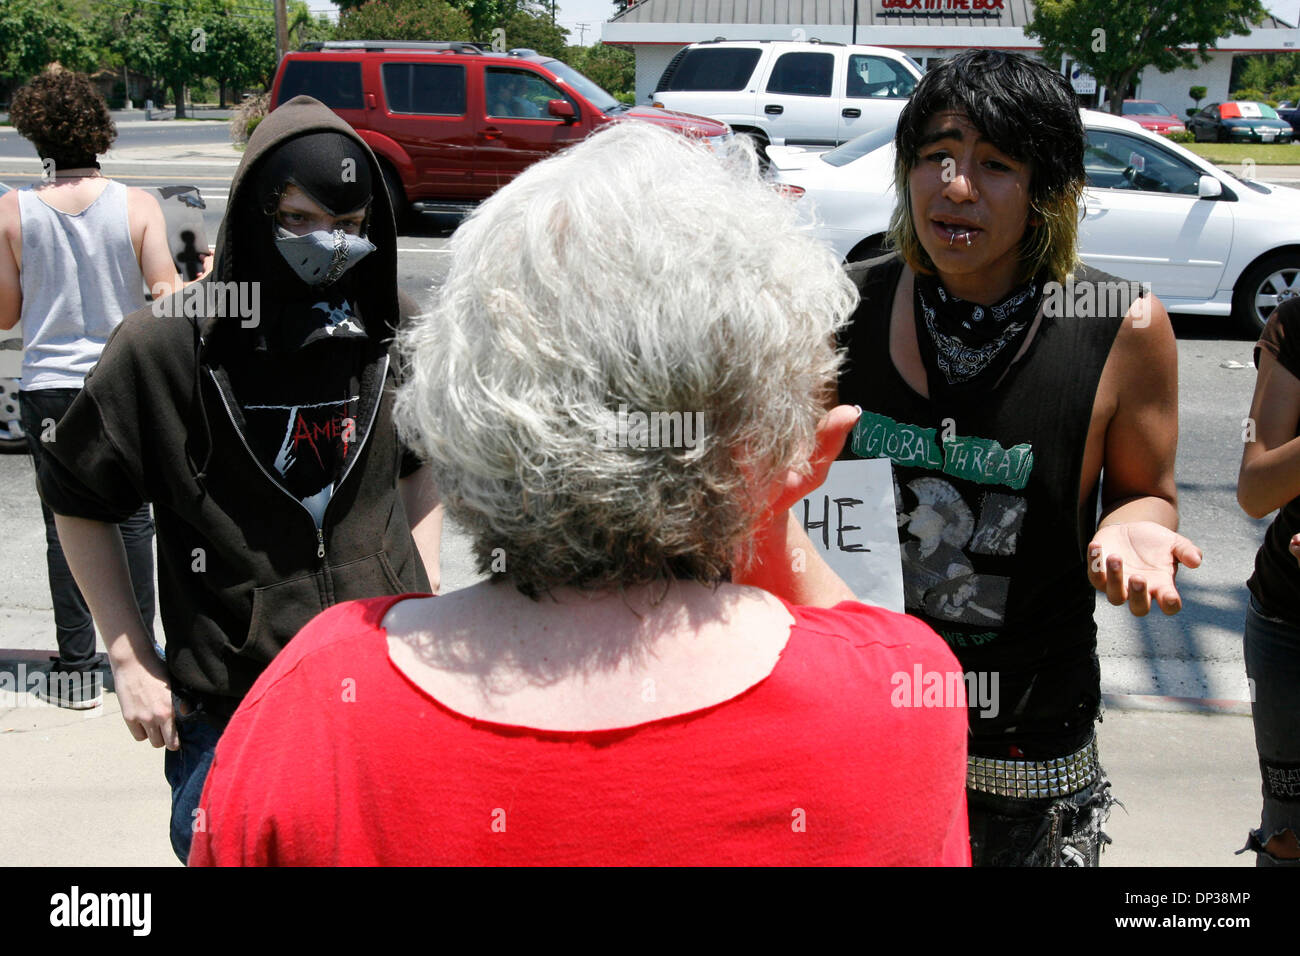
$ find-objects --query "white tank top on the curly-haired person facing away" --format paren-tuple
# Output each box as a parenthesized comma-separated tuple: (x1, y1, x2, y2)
(18, 181, 146, 392)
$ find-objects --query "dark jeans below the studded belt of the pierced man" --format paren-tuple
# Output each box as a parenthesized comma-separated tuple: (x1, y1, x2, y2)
(966, 773, 1115, 866)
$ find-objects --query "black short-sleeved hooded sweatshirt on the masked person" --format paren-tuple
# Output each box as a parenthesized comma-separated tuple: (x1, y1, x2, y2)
(39, 96, 429, 715)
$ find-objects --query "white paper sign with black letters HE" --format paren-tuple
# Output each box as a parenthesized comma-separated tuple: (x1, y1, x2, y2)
(794, 458, 904, 613)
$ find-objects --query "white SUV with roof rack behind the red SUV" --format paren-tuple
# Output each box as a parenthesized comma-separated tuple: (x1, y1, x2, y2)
(653, 40, 920, 154)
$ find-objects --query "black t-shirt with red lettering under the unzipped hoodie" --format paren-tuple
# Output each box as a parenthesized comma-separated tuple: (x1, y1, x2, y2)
(230, 299, 369, 527)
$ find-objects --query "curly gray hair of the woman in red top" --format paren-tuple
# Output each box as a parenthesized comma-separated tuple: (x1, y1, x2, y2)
(395, 122, 857, 597)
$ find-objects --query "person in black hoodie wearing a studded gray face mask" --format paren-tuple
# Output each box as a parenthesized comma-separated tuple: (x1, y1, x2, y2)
(39, 96, 442, 861)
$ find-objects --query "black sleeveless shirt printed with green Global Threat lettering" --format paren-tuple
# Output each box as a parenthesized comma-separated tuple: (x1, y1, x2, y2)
(840, 256, 1132, 758)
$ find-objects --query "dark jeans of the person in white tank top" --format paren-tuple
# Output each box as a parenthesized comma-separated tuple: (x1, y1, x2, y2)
(18, 389, 153, 671)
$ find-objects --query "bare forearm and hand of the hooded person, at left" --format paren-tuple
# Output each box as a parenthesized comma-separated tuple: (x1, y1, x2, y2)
(55, 514, 181, 750)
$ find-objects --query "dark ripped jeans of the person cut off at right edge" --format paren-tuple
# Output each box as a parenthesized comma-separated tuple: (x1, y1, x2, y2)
(1238, 594, 1300, 866)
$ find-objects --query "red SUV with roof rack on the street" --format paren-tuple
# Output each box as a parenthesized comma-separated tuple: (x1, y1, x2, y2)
(270, 40, 731, 219)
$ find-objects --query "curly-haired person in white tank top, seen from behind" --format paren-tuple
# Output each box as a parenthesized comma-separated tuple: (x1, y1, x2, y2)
(0, 65, 202, 709)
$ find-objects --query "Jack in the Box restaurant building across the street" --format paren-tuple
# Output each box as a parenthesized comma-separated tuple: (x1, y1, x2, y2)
(601, 0, 1300, 116)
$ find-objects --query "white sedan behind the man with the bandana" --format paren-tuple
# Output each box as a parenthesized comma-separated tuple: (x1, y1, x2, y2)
(770, 111, 1300, 334)
